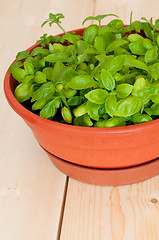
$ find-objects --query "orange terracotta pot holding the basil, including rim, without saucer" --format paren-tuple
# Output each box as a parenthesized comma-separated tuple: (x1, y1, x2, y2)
(4, 29, 159, 171)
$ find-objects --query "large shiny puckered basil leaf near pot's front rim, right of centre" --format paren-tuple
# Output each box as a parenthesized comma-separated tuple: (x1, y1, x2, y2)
(114, 96, 141, 117)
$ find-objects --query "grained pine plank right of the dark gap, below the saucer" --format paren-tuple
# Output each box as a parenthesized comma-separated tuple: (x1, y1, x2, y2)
(60, 176, 159, 240)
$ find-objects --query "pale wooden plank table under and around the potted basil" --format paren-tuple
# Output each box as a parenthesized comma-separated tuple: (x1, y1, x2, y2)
(0, 0, 159, 240)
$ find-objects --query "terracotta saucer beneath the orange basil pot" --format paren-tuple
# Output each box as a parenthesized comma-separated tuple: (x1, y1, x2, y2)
(45, 150, 159, 186)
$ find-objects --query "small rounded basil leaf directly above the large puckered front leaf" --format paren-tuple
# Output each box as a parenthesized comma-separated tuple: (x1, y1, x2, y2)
(116, 83, 133, 98)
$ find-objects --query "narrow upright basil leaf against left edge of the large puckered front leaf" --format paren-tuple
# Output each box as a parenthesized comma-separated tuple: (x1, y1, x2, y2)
(105, 95, 117, 117)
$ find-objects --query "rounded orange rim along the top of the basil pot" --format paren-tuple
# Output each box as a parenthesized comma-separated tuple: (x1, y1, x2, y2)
(4, 28, 159, 134)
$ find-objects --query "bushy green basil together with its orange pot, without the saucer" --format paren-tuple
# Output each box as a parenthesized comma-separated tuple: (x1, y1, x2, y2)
(4, 13, 159, 186)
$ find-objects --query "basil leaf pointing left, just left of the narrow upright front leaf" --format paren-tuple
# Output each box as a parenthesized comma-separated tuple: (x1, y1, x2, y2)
(84, 89, 108, 104)
